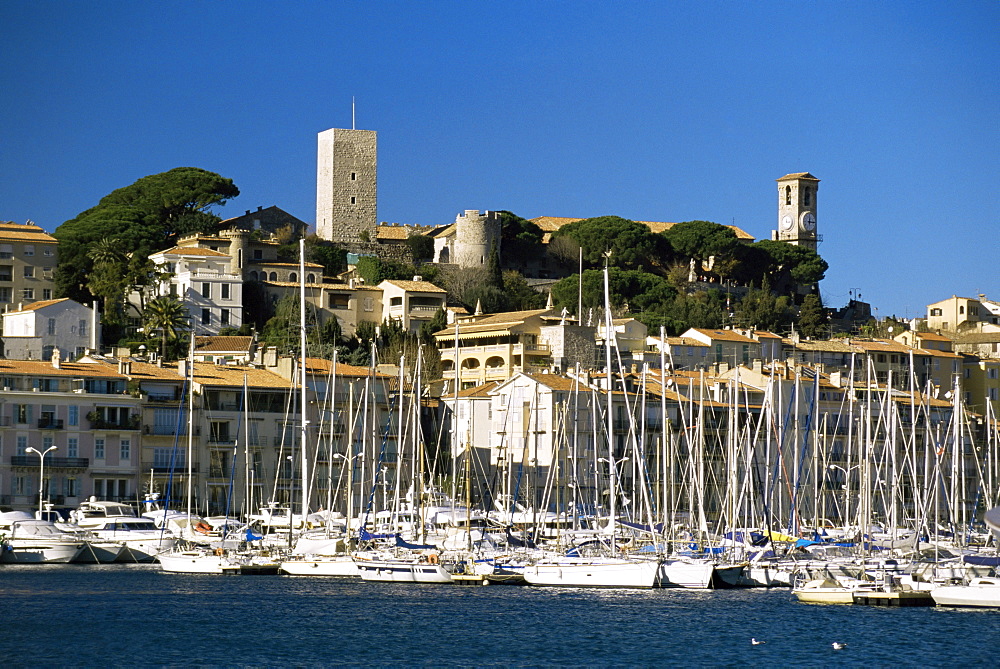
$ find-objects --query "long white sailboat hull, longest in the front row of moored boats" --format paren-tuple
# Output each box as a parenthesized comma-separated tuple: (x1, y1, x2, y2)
(524, 556, 660, 588)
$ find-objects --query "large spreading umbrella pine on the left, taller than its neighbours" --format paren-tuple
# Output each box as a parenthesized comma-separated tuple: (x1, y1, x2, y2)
(53, 167, 239, 302)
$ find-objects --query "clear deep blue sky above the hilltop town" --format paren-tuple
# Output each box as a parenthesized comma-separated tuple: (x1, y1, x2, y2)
(0, 0, 1000, 316)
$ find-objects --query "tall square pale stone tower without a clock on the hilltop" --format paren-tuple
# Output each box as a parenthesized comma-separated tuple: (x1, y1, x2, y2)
(316, 128, 378, 242)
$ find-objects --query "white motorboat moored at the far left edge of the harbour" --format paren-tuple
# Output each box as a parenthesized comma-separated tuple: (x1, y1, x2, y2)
(0, 511, 87, 564)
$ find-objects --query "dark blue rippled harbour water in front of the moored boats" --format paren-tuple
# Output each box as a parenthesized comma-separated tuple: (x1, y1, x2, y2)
(0, 565, 1000, 667)
